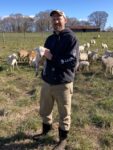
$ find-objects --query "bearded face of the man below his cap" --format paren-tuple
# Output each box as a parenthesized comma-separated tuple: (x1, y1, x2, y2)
(51, 14, 67, 31)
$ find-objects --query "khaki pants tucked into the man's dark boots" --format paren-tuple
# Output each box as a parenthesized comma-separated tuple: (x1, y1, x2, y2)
(40, 82, 73, 131)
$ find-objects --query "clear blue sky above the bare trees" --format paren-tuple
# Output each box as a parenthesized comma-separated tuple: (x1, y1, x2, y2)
(0, 0, 113, 27)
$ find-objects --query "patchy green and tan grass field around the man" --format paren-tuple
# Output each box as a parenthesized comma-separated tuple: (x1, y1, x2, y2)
(0, 32, 113, 150)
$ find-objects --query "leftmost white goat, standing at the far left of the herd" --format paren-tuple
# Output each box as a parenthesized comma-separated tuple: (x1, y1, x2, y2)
(7, 53, 18, 72)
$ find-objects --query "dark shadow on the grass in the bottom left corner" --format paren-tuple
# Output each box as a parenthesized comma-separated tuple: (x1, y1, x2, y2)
(0, 132, 56, 150)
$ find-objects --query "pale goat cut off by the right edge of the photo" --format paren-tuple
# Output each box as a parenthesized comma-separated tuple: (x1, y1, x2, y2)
(102, 55, 113, 75)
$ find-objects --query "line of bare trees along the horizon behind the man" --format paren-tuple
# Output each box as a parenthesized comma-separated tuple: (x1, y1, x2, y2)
(0, 10, 112, 32)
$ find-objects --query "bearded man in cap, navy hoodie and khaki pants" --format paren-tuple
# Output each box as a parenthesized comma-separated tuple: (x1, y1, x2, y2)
(33, 10, 79, 150)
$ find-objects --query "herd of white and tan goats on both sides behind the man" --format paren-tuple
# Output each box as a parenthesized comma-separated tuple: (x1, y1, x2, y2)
(4, 35, 113, 75)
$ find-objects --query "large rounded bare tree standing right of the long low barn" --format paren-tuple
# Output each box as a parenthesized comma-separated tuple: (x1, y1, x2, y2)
(88, 11, 108, 30)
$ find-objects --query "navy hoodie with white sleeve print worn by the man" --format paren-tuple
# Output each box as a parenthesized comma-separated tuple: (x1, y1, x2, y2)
(42, 29, 79, 85)
